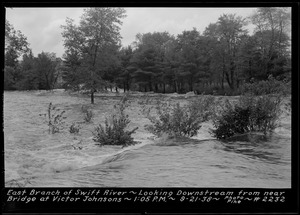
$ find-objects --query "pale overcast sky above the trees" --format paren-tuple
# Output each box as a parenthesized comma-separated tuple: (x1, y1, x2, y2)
(6, 8, 255, 57)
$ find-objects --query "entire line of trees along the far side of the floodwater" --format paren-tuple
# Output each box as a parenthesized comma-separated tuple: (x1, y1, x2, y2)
(4, 7, 291, 103)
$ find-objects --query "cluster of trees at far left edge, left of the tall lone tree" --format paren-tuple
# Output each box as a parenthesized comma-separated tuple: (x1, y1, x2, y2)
(4, 20, 62, 90)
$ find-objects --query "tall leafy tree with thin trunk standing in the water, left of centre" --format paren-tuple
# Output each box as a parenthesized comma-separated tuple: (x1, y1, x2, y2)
(62, 8, 125, 104)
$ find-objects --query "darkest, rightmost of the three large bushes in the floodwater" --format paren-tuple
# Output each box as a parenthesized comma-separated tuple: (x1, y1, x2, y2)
(213, 96, 282, 139)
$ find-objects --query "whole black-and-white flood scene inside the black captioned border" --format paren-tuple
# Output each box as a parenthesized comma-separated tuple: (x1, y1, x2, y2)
(3, 6, 292, 189)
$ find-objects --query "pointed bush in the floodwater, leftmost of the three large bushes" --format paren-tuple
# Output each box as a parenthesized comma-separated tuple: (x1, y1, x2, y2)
(93, 96, 138, 147)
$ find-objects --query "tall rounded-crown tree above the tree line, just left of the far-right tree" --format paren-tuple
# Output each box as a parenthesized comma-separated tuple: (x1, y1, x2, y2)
(204, 14, 247, 90)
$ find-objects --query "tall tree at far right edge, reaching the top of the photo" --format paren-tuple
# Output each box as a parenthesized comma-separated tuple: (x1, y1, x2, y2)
(250, 7, 291, 79)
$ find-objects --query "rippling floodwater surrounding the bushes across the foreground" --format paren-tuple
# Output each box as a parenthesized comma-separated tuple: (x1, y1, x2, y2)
(4, 90, 291, 188)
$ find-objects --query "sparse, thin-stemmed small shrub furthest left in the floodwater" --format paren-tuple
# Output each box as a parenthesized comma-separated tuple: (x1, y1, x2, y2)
(40, 102, 66, 134)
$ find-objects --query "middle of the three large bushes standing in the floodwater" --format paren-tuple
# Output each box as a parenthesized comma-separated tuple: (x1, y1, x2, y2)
(146, 96, 214, 137)
